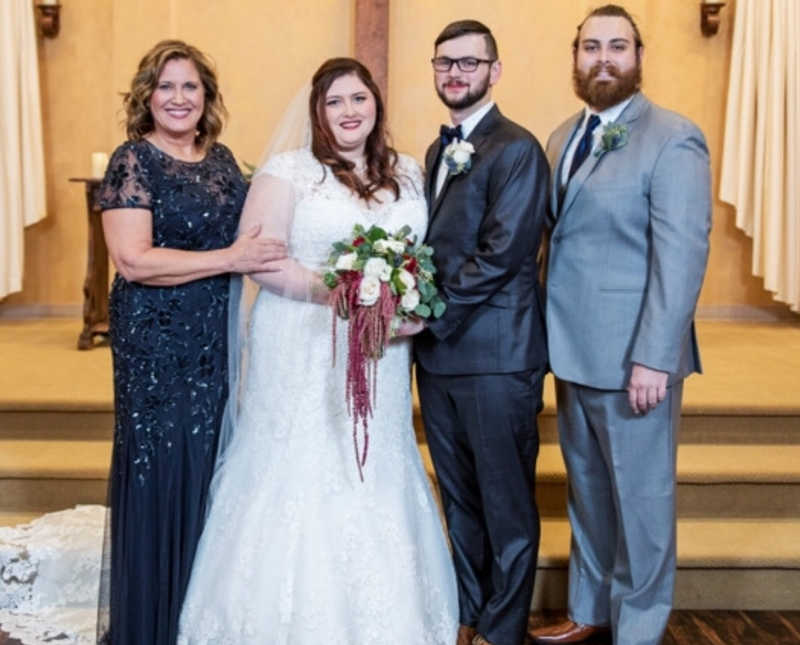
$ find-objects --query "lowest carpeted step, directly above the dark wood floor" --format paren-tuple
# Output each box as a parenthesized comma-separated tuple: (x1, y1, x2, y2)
(533, 519, 800, 611)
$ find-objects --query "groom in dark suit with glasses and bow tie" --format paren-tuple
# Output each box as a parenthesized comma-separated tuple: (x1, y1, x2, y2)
(415, 20, 549, 645)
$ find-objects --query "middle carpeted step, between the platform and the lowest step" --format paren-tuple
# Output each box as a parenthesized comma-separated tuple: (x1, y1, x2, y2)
(0, 439, 800, 519)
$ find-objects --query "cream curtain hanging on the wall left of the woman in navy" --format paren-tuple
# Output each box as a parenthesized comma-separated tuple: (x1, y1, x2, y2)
(0, 0, 47, 298)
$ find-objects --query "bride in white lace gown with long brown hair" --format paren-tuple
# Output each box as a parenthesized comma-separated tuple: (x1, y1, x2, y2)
(179, 58, 458, 645)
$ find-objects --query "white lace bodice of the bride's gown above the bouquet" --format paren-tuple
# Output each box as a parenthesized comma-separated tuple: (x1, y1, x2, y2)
(259, 148, 427, 266)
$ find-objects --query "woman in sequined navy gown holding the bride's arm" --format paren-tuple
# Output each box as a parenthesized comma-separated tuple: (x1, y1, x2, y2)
(98, 41, 285, 645)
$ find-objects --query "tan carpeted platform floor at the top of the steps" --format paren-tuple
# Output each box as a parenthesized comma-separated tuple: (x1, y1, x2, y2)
(0, 318, 800, 414)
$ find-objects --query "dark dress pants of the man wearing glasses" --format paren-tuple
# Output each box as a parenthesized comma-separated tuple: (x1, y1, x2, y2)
(417, 364, 544, 645)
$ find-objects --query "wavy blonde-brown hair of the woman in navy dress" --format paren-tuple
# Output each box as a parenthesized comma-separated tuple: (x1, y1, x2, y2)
(123, 40, 228, 150)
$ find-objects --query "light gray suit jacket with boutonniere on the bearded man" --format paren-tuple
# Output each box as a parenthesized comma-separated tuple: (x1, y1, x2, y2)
(546, 93, 711, 390)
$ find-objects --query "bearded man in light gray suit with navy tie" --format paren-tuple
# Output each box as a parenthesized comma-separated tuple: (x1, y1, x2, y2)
(530, 5, 711, 645)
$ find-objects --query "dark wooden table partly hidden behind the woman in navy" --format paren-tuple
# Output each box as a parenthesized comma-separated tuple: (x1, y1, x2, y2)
(70, 177, 108, 349)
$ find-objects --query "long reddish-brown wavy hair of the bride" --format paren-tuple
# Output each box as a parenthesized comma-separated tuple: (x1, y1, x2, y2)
(309, 58, 400, 202)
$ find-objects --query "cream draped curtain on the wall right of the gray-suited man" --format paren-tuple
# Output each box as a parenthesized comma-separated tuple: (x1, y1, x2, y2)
(719, 0, 800, 312)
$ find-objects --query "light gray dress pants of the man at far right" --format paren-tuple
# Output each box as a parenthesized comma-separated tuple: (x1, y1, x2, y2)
(556, 380, 683, 645)
